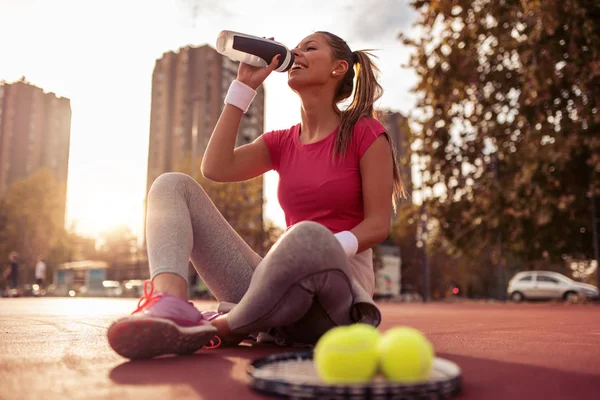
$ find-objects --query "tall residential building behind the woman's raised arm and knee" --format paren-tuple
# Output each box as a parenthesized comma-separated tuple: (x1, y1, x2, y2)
(146, 46, 265, 252)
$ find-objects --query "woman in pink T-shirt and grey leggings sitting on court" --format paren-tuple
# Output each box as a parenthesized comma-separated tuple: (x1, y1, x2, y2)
(108, 32, 404, 359)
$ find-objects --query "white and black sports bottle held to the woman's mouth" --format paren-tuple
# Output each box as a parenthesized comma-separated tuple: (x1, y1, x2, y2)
(217, 31, 294, 72)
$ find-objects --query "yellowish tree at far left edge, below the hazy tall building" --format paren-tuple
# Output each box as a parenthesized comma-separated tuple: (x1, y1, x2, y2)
(0, 169, 64, 279)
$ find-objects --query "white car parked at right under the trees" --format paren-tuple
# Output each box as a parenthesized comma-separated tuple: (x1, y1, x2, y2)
(507, 271, 598, 302)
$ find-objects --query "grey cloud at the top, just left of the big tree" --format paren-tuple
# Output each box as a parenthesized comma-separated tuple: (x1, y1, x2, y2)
(346, 0, 415, 42)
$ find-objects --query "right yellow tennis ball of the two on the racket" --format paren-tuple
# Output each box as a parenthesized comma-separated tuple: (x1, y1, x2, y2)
(379, 327, 435, 383)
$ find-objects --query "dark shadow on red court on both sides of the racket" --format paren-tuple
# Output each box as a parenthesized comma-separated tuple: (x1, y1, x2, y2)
(109, 346, 600, 400)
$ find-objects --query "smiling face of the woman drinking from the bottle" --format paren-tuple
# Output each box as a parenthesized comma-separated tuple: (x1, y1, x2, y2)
(288, 33, 335, 91)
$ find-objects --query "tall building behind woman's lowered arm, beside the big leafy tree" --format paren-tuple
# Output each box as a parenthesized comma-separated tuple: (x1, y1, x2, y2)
(377, 110, 413, 197)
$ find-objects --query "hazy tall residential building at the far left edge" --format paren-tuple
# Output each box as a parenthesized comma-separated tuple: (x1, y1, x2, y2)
(0, 78, 71, 219)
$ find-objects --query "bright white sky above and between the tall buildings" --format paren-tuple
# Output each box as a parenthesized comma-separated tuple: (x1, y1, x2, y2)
(0, 0, 416, 241)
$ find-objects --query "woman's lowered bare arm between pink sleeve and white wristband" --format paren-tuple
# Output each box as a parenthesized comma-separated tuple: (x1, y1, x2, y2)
(351, 135, 394, 253)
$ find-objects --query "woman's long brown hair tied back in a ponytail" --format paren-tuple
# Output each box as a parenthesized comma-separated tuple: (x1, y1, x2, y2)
(316, 31, 407, 210)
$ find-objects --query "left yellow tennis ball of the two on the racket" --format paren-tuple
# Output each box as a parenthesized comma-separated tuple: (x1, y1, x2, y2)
(314, 324, 380, 384)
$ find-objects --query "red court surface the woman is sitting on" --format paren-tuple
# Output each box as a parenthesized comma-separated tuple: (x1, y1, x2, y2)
(0, 298, 600, 400)
